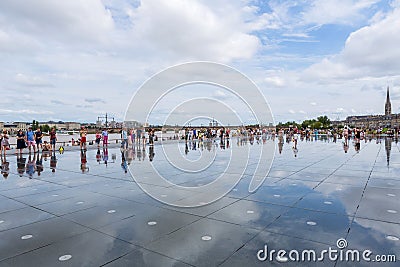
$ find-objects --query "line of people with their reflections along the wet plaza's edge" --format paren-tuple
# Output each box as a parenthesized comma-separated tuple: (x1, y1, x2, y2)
(0, 124, 396, 178)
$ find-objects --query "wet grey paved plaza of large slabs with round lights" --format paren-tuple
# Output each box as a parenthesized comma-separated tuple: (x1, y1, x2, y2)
(0, 138, 400, 266)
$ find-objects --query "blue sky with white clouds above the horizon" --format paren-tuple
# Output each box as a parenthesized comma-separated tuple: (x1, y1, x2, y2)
(0, 0, 400, 125)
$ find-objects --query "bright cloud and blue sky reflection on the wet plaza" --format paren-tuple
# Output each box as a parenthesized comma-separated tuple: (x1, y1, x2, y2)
(0, 138, 400, 266)
